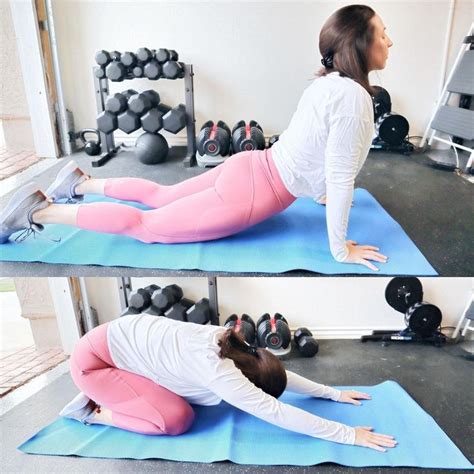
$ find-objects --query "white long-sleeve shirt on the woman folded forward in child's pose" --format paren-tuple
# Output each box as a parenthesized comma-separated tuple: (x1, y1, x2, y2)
(107, 314, 355, 444)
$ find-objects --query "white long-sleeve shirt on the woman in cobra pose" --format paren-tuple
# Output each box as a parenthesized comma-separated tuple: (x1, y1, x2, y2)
(272, 72, 374, 262)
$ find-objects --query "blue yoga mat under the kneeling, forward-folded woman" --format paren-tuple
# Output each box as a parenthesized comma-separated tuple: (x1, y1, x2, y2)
(18, 381, 473, 469)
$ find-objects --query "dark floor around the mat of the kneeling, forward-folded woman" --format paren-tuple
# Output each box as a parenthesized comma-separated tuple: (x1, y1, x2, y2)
(0, 340, 474, 474)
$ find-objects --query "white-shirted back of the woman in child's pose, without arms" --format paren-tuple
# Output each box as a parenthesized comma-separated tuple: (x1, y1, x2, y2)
(108, 314, 227, 405)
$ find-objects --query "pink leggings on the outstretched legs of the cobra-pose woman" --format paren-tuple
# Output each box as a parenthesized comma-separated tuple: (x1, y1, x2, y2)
(77, 150, 295, 243)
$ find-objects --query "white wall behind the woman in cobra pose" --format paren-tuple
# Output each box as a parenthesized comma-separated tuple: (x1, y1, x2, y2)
(50, 0, 472, 141)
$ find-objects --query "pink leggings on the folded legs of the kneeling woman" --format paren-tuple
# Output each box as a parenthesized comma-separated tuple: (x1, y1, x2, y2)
(70, 324, 194, 435)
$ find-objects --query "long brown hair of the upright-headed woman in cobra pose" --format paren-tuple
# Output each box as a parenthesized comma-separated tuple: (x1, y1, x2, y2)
(317, 5, 375, 95)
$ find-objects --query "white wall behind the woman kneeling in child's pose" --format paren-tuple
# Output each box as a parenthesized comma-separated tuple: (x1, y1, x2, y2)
(88, 277, 474, 338)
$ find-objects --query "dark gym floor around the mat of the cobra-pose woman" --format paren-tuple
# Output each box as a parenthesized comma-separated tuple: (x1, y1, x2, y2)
(0, 147, 474, 277)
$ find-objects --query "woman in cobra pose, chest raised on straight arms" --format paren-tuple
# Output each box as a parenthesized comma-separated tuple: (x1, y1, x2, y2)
(0, 5, 392, 271)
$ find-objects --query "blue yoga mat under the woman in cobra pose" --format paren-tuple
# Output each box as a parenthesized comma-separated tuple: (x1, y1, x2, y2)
(0, 189, 437, 276)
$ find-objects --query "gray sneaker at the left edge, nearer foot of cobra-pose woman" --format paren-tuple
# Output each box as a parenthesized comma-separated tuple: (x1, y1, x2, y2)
(0, 183, 49, 244)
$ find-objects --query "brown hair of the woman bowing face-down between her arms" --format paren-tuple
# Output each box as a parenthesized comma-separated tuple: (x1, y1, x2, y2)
(219, 329, 287, 398)
